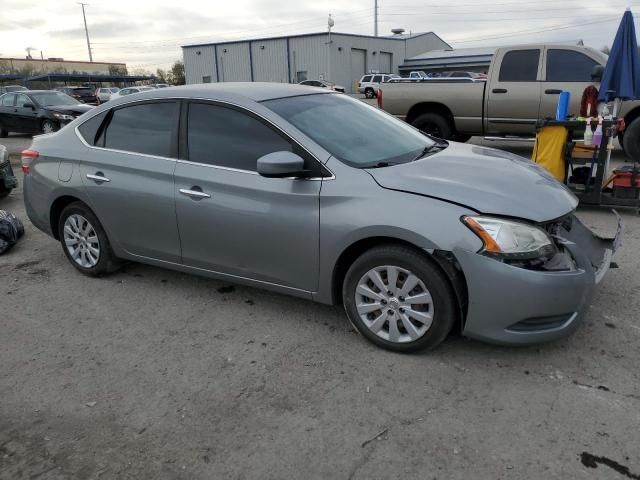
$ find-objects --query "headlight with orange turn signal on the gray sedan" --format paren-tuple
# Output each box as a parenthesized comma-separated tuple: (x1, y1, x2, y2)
(462, 216, 557, 259)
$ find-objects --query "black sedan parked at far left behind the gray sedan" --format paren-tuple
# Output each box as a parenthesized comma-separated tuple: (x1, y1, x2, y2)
(0, 90, 93, 138)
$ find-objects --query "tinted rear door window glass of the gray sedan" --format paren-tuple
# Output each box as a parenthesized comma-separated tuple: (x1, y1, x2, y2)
(104, 102, 180, 157)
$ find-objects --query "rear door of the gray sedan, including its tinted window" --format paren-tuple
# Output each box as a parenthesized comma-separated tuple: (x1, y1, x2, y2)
(79, 101, 180, 263)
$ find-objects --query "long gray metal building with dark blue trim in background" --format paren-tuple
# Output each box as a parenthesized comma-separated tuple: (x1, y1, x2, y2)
(182, 32, 451, 93)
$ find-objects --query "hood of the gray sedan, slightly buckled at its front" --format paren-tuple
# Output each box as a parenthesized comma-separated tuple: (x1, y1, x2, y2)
(368, 142, 578, 222)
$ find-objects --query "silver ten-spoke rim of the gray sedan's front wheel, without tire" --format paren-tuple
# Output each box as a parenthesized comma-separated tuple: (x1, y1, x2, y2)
(355, 265, 434, 343)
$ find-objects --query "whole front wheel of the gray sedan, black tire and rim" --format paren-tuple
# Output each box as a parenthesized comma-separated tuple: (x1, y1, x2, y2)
(342, 245, 459, 353)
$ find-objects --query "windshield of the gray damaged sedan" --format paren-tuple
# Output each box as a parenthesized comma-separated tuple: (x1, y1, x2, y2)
(263, 94, 435, 168)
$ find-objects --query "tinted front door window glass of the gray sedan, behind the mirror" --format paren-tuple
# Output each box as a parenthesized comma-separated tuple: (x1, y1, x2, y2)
(187, 103, 292, 172)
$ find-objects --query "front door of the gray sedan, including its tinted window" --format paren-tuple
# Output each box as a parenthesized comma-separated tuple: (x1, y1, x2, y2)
(175, 102, 321, 291)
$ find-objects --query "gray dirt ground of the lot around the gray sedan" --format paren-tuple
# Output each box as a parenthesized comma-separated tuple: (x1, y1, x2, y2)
(0, 132, 640, 480)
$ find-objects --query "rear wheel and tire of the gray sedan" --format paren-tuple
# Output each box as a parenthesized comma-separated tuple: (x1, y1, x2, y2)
(58, 202, 121, 277)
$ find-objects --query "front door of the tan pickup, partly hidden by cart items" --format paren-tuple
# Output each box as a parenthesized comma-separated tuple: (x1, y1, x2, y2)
(540, 47, 600, 118)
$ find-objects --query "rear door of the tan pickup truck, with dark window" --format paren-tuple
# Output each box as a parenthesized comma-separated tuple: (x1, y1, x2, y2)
(486, 48, 542, 135)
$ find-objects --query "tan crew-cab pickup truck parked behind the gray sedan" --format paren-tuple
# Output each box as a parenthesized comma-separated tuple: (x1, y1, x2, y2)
(381, 44, 640, 155)
